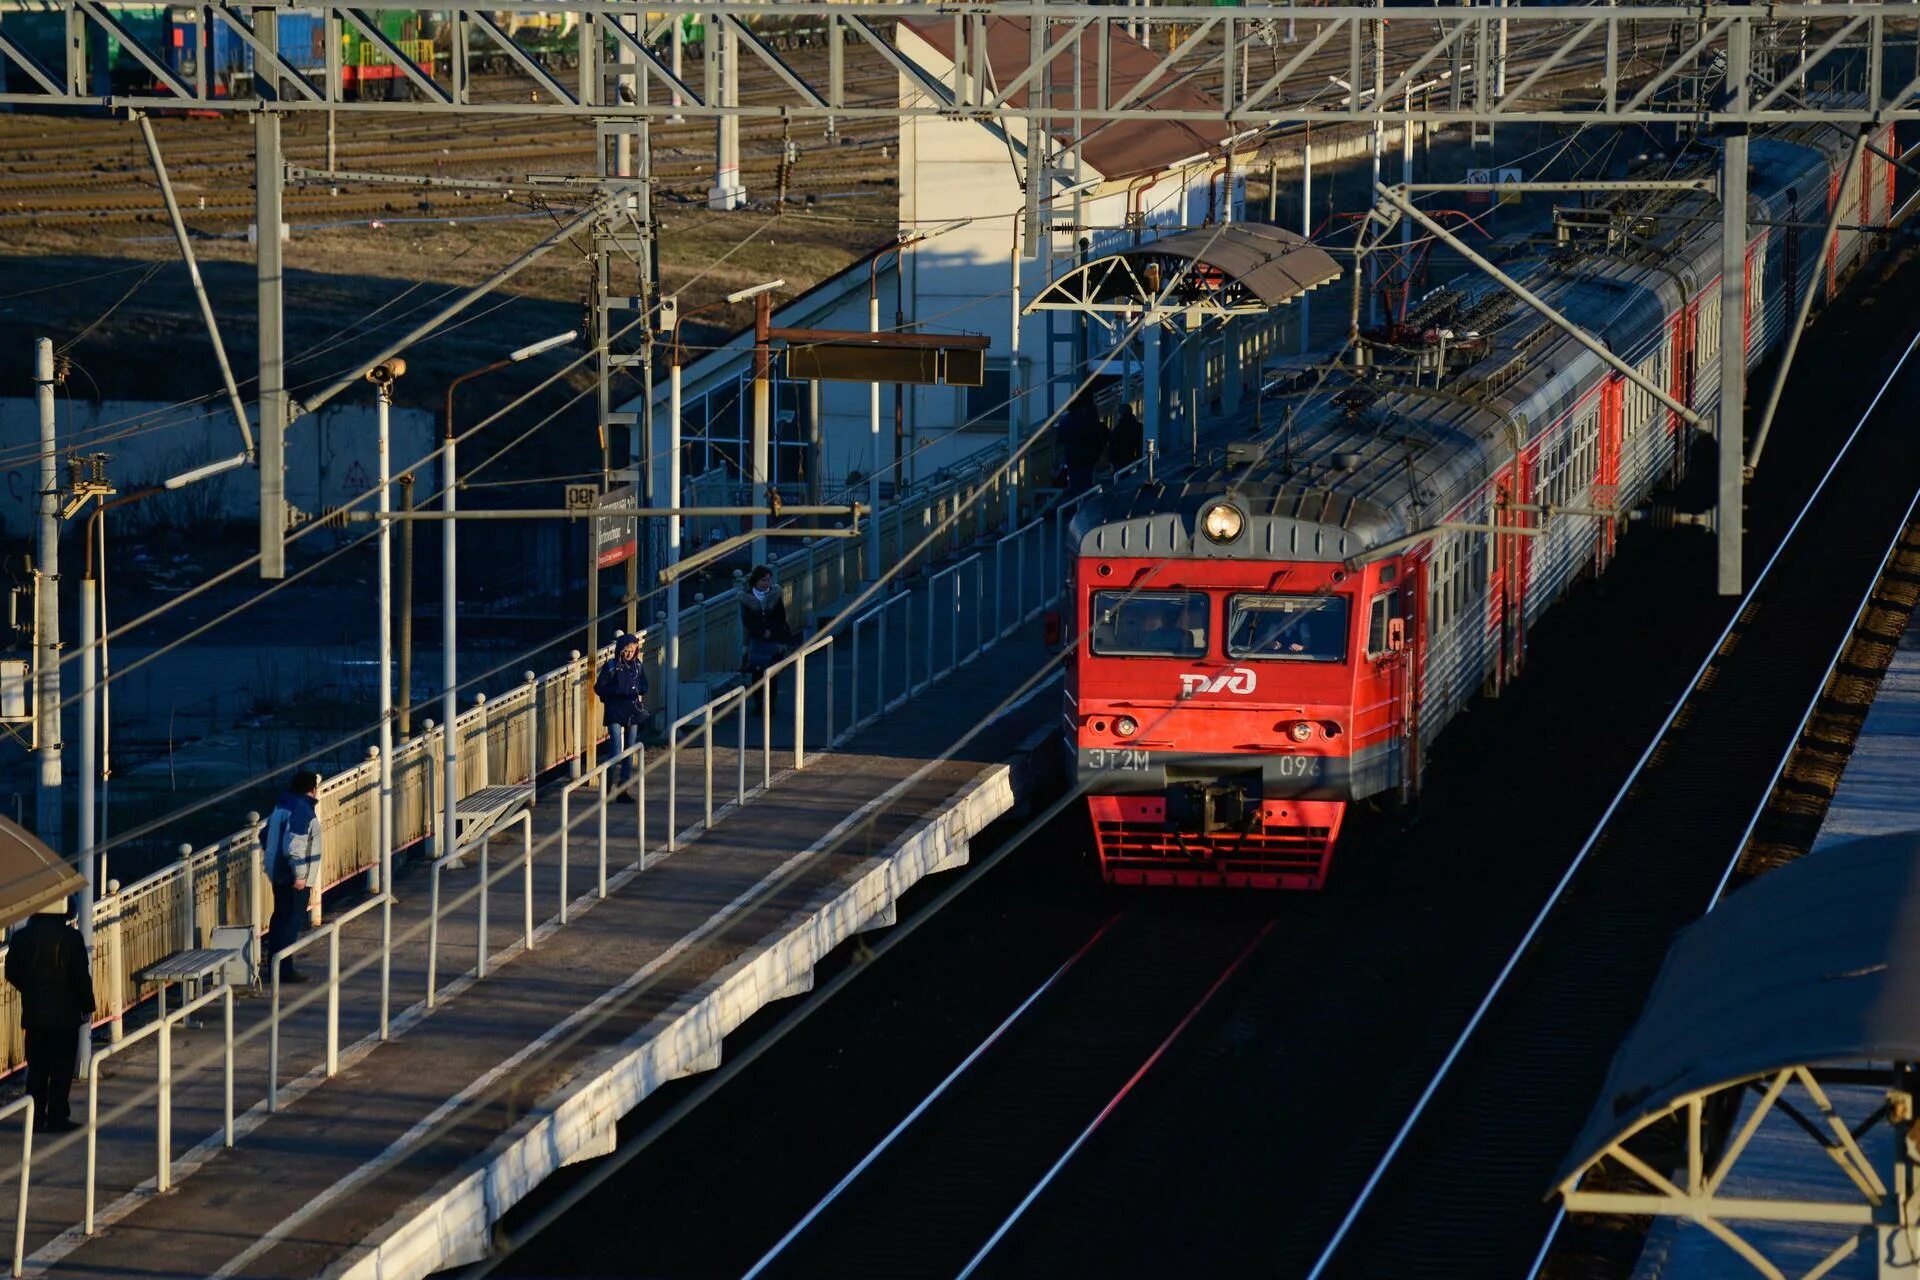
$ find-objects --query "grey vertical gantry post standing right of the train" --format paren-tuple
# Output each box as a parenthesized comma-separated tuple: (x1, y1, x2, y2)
(1715, 17, 1753, 595)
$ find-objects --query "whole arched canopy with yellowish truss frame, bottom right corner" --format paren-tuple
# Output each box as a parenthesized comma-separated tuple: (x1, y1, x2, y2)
(1553, 831, 1920, 1274)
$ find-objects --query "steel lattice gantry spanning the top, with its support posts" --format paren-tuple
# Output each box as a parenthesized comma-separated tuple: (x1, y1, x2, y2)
(0, 0, 1920, 591)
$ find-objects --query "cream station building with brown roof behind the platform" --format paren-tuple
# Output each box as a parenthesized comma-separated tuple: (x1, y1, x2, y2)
(626, 17, 1313, 514)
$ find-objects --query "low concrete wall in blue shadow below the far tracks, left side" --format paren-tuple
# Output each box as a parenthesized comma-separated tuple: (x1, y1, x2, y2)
(0, 395, 436, 537)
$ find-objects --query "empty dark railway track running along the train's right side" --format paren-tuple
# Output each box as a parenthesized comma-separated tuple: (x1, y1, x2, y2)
(1311, 338, 1920, 1276)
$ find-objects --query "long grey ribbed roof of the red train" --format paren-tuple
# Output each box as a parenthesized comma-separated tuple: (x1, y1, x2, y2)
(1073, 127, 1845, 560)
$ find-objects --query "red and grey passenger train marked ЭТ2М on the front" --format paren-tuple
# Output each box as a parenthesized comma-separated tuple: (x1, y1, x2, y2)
(1064, 129, 1899, 889)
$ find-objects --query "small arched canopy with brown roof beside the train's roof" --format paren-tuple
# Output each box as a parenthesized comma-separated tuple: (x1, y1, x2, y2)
(1025, 223, 1340, 328)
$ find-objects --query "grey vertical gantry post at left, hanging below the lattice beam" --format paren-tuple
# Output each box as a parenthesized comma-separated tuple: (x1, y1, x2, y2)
(253, 73, 288, 578)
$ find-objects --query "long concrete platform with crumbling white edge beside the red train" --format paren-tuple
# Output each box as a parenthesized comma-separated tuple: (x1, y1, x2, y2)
(0, 606, 1060, 1280)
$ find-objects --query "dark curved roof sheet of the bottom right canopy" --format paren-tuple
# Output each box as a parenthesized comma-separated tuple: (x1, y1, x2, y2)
(1555, 831, 1920, 1186)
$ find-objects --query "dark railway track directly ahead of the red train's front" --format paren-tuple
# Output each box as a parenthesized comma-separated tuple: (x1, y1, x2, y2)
(747, 900, 1292, 1278)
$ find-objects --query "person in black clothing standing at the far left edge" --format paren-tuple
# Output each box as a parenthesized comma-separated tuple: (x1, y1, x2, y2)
(6, 898, 94, 1134)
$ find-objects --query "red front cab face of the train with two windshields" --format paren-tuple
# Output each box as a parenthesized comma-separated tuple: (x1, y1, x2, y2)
(1066, 555, 1405, 889)
